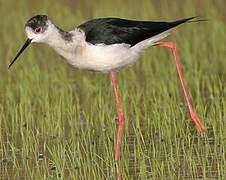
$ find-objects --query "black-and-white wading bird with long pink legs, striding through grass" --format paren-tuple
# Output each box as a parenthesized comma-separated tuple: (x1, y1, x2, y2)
(9, 15, 204, 176)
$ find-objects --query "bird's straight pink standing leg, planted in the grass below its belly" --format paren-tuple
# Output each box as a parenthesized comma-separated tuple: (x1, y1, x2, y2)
(111, 72, 125, 179)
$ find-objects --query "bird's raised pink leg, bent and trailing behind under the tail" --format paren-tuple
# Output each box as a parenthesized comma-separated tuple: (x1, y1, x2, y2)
(157, 42, 205, 136)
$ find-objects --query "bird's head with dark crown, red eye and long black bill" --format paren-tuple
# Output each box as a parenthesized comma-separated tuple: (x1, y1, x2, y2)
(9, 15, 52, 68)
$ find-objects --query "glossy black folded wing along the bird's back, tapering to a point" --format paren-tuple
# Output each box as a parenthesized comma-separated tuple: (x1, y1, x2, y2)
(78, 17, 196, 46)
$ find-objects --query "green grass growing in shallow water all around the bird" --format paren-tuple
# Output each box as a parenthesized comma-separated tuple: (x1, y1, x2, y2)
(0, 0, 226, 179)
